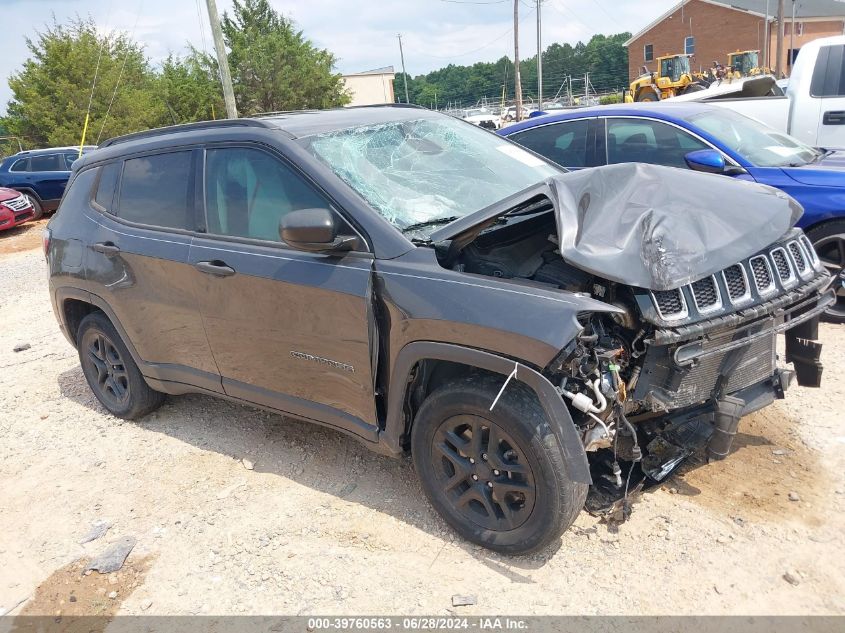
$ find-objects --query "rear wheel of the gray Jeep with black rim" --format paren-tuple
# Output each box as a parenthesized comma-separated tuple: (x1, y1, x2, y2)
(76, 312, 165, 420)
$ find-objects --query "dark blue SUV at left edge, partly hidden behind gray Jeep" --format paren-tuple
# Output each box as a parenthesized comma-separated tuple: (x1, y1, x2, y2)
(0, 146, 94, 218)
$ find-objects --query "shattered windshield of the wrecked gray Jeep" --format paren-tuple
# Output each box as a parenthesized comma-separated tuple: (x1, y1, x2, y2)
(306, 116, 560, 231)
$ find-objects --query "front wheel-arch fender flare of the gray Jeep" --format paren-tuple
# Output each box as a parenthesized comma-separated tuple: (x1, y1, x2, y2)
(380, 341, 592, 484)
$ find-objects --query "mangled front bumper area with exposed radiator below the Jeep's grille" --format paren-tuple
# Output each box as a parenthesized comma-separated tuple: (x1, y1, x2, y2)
(587, 276, 836, 519)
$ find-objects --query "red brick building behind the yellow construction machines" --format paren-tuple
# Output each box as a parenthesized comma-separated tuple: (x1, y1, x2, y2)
(625, 0, 845, 79)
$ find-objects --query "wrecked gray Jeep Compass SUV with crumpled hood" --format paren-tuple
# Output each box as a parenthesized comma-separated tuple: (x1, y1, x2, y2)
(45, 106, 834, 553)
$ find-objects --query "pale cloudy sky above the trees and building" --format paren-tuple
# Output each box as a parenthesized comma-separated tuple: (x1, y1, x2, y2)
(0, 0, 677, 113)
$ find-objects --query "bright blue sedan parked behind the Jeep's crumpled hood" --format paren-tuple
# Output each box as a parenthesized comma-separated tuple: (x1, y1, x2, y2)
(498, 102, 845, 323)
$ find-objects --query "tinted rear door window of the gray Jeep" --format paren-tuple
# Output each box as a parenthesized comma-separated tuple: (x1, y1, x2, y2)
(116, 151, 194, 230)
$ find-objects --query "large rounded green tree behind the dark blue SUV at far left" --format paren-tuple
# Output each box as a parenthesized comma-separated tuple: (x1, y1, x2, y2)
(4, 18, 164, 146)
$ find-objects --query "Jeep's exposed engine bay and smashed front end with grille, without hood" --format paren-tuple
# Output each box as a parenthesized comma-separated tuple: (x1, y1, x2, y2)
(435, 199, 830, 519)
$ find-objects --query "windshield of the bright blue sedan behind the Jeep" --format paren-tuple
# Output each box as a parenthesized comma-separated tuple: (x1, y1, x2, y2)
(684, 108, 822, 167)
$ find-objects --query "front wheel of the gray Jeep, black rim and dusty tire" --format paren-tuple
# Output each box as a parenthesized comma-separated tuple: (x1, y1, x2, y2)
(411, 376, 588, 554)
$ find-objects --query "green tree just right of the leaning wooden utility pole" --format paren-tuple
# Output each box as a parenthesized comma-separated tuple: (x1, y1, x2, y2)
(223, 0, 350, 116)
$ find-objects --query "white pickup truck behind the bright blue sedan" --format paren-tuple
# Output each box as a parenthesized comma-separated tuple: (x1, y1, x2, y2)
(672, 35, 845, 149)
